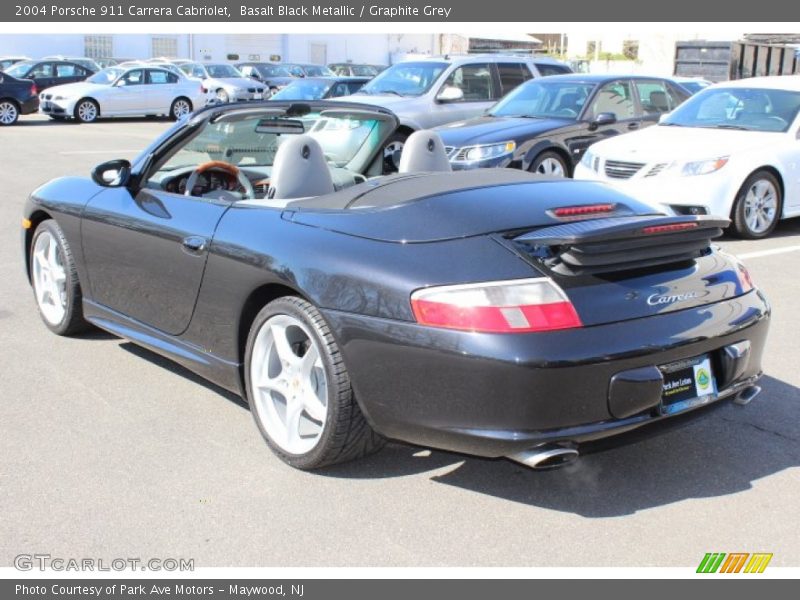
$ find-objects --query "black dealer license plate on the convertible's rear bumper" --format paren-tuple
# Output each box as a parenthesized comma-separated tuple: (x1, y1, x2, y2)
(660, 354, 717, 414)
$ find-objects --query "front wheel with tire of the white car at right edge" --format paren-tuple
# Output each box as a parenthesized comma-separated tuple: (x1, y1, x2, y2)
(731, 171, 783, 240)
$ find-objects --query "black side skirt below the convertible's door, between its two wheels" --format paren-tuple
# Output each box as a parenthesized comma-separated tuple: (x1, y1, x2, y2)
(83, 298, 245, 398)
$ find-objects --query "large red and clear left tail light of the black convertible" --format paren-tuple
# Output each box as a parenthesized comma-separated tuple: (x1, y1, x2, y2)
(411, 277, 582, 333)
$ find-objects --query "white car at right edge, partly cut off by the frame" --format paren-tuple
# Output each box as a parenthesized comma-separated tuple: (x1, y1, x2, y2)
(575, 76, 800, 239)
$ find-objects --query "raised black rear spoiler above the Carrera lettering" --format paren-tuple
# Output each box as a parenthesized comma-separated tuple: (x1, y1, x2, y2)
(513, 215, 730, 275)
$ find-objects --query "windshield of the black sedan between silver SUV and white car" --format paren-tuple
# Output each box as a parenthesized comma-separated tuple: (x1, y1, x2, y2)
(489, 80, 595, 120)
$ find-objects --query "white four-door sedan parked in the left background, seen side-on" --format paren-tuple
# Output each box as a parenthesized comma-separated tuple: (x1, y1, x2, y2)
(39, 65, 208, 123)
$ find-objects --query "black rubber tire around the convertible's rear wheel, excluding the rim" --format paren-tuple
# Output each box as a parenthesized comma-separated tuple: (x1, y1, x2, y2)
(244, 296, 386, 470)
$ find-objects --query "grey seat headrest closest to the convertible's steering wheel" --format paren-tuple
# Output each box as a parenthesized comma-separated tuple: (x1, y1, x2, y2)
(269, 134, 334, 200)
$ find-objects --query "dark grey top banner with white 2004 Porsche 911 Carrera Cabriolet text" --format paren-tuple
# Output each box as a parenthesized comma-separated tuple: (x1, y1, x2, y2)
(0, 0, 796, 23)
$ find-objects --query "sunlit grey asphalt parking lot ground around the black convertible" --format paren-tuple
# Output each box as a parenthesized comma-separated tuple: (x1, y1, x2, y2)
(0, 116, 800, 567)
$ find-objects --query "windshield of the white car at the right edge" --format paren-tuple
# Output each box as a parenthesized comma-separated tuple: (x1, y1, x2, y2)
(661, 87, 800, 132)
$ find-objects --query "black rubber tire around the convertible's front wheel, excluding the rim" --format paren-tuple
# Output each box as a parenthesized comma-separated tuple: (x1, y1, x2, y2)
(28, 219, 91, 335)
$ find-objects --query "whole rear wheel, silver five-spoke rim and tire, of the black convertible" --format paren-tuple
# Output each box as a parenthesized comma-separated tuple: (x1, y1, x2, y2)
(245, 296, 384, 469)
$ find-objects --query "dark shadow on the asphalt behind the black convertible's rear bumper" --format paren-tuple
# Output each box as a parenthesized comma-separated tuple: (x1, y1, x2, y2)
(319, 377, 800, 518)
